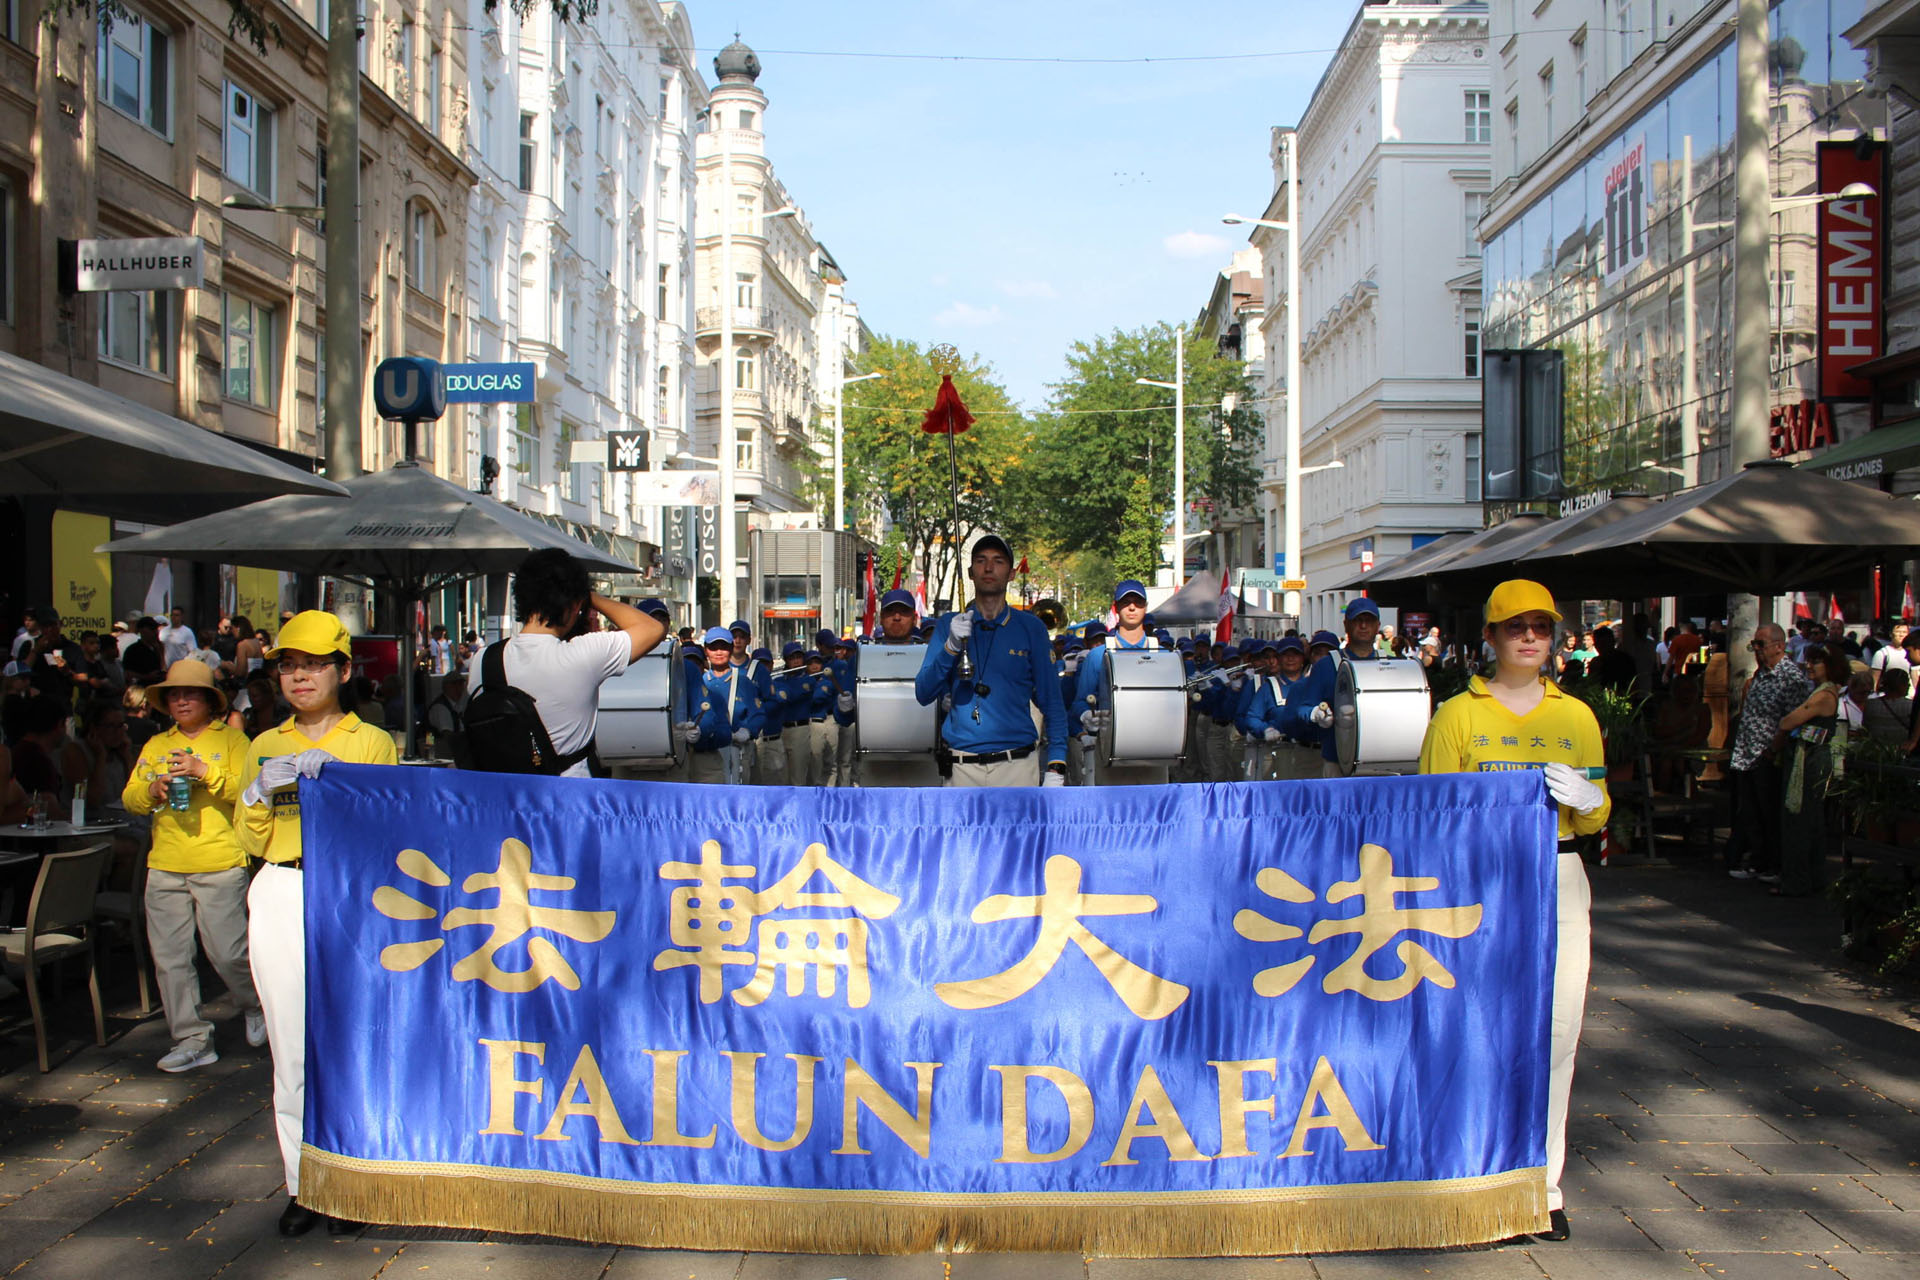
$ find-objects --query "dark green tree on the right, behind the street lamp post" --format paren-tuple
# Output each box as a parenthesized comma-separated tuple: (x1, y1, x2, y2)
(1025, 324, 1261, 571)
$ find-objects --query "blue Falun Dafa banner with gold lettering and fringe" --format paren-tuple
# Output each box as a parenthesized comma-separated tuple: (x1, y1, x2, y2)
(301, 766, 1555, 1257)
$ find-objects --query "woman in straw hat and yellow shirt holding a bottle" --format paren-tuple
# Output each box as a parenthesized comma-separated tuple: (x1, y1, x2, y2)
(115, 658, 267, 1071)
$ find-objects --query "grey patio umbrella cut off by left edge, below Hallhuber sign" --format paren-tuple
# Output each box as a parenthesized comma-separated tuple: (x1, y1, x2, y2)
(0, 351, 346, 522)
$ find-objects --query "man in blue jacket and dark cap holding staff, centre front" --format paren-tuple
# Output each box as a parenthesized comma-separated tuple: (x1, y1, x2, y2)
(914, 533, 1068, 787)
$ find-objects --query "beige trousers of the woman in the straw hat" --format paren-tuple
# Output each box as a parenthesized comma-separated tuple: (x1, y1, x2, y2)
(146, 867, 259, 1048)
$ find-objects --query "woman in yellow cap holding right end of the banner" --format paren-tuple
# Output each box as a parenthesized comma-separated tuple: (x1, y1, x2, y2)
(1421, 580, 1613, 1240)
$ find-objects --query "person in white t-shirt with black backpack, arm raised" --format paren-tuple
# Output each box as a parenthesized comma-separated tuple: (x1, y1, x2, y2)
(474, 547, 666, 777)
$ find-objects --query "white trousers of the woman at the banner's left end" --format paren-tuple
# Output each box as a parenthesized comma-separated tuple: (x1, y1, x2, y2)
(246, 862, 307, 1197)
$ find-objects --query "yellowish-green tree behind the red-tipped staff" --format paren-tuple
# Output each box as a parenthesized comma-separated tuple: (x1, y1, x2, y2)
(841, 338, 1031, 599)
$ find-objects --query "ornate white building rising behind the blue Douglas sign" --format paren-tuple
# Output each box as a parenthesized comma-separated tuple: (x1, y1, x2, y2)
(464, 0, 707, 603)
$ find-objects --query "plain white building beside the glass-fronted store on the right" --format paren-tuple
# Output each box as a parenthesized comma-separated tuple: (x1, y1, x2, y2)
(1252, 0, 1494, 629)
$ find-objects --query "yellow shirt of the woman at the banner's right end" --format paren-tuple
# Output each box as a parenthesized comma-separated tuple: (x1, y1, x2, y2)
(1421, 676, 1613, 841)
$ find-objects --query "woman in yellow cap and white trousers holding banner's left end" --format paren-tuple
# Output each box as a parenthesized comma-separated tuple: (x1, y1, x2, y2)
(240, 610, 397, 1236)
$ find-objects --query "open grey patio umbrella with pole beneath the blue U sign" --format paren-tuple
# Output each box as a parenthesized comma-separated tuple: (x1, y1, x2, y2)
(100, 462, 636, 754)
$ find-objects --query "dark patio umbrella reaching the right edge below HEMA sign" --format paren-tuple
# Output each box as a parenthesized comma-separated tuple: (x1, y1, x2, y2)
(1513, 462, 1920, 597)
